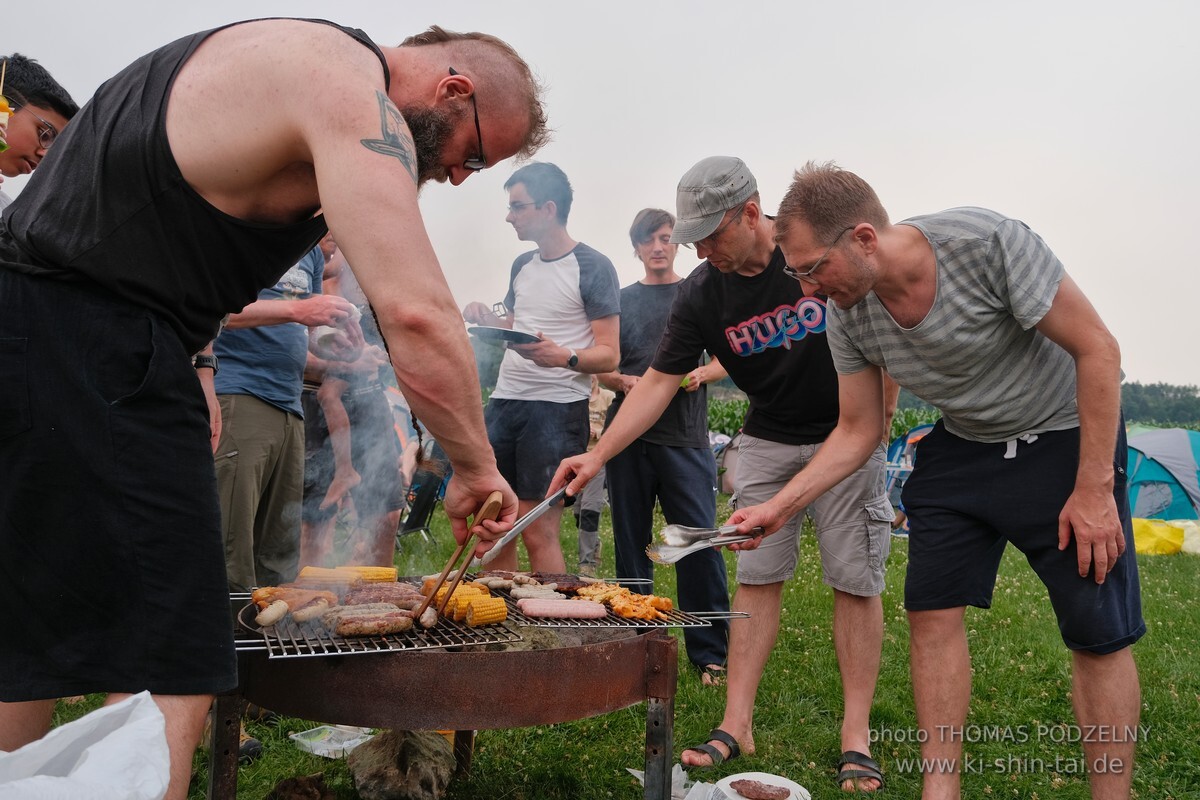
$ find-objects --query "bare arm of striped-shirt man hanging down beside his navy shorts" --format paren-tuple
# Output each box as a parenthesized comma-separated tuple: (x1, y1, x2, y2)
(1037, 275, 1126, 583)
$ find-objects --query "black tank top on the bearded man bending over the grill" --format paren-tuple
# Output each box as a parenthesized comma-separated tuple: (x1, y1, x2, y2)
(0, 19, 390, 353)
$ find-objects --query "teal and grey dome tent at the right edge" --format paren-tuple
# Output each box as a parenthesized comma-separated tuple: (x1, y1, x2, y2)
(1128, 428, 1200, 519)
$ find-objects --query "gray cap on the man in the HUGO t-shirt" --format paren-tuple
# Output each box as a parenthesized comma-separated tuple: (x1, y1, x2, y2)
(671, 156, 758, 245)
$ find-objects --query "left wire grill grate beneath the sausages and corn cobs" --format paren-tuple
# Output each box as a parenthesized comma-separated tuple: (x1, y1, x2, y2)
(235, 603, 521, 658)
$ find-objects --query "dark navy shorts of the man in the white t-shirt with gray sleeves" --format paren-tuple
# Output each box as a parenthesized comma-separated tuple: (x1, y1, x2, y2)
(484, 398, 590, 500)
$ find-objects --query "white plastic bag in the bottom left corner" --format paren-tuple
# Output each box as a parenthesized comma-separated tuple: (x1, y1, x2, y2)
(0, 692, 170, 800)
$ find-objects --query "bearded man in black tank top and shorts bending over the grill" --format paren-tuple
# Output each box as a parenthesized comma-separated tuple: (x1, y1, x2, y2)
(0, 19, 547, 799)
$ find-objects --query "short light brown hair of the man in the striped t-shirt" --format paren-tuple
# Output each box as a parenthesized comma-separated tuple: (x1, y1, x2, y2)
(775, 161, 889, 242)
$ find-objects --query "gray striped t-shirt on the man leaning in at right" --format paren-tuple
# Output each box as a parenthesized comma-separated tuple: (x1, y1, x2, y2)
(828, 207, 1079, 443)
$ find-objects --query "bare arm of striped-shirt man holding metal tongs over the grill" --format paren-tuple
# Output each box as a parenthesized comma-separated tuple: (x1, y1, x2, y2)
(730, 367, 883, 549)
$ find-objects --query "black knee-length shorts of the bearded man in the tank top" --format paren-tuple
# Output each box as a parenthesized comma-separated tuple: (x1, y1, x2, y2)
(0, 269, 238, 700)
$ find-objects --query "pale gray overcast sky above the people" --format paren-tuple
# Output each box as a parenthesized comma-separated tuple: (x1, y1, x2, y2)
(0, 0, 1200, 385)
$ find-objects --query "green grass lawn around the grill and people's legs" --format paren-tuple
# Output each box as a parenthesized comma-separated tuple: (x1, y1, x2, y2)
(60, 510, 1200, 800)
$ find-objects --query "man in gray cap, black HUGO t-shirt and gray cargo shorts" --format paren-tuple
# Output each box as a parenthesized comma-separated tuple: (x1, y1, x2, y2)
(551, 156, 895, 790)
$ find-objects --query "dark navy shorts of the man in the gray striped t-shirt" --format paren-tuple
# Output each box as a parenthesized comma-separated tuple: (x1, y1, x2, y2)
(904, 421, 1146, 655)
